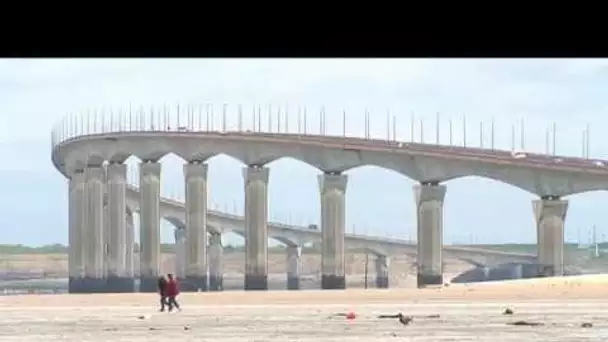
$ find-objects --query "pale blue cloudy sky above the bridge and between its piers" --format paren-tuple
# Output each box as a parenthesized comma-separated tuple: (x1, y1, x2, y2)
(0, 59, 608, 245)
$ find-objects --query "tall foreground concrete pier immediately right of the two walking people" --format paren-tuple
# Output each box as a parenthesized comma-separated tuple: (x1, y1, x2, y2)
(182, 161, 209, 292)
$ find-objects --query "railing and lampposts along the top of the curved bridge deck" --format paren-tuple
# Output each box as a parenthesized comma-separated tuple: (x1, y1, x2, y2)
(51, 104, 608, 168)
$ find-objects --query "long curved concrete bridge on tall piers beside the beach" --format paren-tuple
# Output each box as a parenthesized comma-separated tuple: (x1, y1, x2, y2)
(52, 107, 608, 291)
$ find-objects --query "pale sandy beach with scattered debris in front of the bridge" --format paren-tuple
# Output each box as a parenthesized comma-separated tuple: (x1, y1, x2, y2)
(0, 276, 608, 342)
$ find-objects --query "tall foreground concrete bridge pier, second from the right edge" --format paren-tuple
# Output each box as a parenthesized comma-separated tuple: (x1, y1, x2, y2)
(414, 184, 446, 287)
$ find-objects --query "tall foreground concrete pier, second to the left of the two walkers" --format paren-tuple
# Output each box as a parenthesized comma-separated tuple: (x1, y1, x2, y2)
(106, 163, 133, 292)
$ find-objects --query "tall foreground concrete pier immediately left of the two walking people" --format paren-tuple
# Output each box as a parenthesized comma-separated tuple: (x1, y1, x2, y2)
(139, 161, 161, 292)
